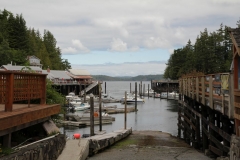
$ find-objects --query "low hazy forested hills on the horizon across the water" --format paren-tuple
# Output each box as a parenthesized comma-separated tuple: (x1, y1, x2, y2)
(91, 74, 163, 81)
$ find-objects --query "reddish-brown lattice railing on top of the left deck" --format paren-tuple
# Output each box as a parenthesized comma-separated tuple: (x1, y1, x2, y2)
(0, 71, 46, 111)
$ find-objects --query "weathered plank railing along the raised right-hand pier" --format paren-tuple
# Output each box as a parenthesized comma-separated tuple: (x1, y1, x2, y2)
(179, 73, 234, 118)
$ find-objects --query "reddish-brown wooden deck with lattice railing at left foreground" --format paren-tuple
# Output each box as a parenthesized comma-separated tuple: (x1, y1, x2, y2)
(0, 71, 61, 147)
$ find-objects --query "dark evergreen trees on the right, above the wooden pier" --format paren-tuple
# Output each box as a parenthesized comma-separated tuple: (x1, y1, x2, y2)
(164, 20, 240, 80)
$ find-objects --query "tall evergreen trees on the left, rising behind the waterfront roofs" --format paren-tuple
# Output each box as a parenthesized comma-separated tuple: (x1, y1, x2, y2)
(0, 9, 71, 70)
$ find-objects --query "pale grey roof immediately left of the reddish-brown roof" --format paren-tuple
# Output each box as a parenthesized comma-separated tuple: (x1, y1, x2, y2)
(42, 70, 72, 79)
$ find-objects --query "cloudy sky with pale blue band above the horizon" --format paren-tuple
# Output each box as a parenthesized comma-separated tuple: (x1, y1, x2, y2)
(0, 0, 240, 76)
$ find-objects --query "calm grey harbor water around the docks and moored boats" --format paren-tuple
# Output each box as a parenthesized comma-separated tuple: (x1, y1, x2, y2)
(62, 81, 178, 137)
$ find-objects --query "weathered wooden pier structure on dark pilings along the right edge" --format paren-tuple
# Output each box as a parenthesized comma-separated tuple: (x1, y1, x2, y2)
(178, 28, 240, 160)
